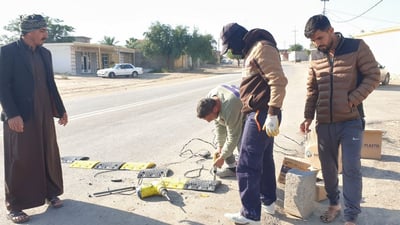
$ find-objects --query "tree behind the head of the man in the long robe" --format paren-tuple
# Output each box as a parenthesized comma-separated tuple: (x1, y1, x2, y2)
(0, 16, 75, 44)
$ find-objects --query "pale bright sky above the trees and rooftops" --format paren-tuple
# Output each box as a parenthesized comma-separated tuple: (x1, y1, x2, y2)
(0, 0, 400, 48)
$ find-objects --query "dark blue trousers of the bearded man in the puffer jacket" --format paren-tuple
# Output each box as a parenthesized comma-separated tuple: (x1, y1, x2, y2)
(316, 119, 364, 221)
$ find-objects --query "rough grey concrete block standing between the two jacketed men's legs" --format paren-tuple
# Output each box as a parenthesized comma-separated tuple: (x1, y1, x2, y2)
(284, 169, 317, 219)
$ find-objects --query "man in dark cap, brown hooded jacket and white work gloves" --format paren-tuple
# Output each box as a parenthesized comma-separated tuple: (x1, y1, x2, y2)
(221, 23, 287, 224)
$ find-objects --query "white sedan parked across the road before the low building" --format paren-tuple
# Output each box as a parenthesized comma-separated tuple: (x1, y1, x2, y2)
(97, 63, 143, 78)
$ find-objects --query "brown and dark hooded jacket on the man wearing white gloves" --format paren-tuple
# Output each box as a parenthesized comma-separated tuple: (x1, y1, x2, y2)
(240, 29, 288, 115)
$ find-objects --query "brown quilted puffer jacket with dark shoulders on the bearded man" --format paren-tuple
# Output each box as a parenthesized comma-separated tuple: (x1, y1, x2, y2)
(304, 33, 380, 123)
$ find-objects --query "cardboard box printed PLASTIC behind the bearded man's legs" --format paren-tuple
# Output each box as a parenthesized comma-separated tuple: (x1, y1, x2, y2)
(361, 130, 383, 159)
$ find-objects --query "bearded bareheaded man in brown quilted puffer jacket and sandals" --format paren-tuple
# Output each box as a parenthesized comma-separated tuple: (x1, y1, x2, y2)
(300, 15, 379, 225)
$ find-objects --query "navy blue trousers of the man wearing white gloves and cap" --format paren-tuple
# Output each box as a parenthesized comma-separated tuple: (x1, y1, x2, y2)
(236, 111, 280, 221)
